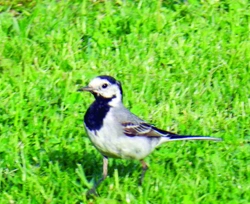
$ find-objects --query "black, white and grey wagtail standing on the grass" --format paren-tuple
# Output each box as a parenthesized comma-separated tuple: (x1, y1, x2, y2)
(78, 75, 221, 193)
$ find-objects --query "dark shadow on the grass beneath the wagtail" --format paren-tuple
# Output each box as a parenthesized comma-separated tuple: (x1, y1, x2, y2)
(47, 147, 141, 181)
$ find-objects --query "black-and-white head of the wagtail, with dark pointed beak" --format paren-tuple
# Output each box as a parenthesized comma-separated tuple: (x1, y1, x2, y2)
(78, 75, 122, 106)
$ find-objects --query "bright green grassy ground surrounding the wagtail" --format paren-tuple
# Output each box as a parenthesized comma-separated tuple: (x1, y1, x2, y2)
(0, 0, 250, 204)
